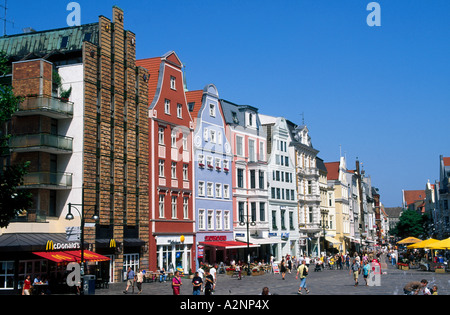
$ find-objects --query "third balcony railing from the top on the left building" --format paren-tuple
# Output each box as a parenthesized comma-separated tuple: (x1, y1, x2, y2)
(21, 172, 72, 189)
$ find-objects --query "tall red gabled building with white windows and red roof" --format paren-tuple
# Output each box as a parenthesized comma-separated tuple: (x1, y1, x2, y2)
(136, 51, 195, 273)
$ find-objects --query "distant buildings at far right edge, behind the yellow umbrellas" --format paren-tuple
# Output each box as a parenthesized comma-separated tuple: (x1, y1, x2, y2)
(402, 155, 450, 239)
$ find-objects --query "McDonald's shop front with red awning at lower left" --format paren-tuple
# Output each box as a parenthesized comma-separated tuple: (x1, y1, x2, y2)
(0, 233, 109, 294)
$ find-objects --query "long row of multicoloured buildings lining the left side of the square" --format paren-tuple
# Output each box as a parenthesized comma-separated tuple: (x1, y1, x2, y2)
(0, 6, 381, 292)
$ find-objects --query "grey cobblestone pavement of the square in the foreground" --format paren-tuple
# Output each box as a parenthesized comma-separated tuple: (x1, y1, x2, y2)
(95, 256, 450, 296)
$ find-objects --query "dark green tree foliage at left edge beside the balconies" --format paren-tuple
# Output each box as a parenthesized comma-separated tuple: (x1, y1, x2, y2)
(0, 52, 32, 228)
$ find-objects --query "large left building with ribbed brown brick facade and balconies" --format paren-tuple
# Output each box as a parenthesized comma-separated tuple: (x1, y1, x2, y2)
(0, 7, 148, 290)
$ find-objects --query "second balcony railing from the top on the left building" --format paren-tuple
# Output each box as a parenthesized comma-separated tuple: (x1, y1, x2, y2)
(9, 133, 73, 153)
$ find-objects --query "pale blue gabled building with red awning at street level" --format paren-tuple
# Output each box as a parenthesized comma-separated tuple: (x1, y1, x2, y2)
(186, 84, 234, 268)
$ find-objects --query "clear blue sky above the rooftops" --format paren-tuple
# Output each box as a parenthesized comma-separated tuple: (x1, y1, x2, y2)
(4, 0, 450, 207)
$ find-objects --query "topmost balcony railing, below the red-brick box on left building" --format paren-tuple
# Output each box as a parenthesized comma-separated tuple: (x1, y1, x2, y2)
(16, 95, 73, 119)
